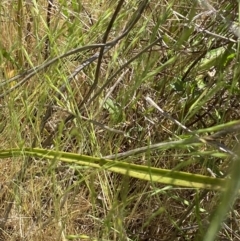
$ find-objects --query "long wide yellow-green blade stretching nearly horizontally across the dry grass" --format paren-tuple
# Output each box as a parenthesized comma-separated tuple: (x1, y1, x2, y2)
(0, 148, 226, 190)
